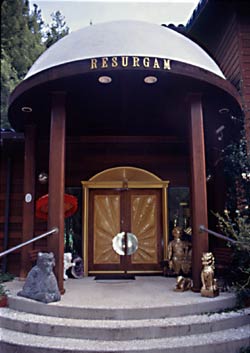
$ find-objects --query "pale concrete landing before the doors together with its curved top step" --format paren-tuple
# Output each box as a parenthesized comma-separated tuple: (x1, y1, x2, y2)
(7, 276, 235, 318)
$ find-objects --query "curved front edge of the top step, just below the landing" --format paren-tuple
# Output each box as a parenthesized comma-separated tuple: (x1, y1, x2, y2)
(8, 293, 236, 320)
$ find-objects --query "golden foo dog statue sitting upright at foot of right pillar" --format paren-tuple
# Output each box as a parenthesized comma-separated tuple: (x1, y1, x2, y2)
(201, 252, 219, 298)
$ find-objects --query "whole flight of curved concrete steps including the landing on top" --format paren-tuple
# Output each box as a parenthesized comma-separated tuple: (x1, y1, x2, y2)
(0, 277, 250, 353)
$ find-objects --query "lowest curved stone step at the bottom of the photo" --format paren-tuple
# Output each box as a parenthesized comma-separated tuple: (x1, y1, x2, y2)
(0, 325, 250, 353)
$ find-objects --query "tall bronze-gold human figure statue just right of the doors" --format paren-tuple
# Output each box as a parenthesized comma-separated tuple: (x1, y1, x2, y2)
(168, 227, 192, 275)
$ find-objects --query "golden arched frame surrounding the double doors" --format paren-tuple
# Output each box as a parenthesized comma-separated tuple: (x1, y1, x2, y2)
(81, 167, 169, 276)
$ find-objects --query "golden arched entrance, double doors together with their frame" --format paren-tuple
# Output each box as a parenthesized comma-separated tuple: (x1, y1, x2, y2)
(82, 167, 169, 276)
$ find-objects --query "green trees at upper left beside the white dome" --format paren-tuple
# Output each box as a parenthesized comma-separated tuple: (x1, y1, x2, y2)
(1, 0, 69, 128)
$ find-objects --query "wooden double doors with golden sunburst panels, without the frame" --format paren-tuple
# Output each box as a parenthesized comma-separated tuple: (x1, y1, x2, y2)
(88, 189, 162, 273)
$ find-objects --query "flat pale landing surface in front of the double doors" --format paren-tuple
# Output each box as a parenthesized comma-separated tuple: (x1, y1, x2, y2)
(6, 276, 236, 309)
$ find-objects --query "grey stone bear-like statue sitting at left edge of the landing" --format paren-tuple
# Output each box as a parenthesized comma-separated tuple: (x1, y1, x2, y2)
(17, 252, 61, 303)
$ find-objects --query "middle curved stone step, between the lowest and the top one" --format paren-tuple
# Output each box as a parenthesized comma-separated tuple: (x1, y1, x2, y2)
(0, 308, 250, 341)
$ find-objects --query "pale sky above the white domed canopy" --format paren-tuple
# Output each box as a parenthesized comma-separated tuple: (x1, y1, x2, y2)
(30, 0, 199, 31)
